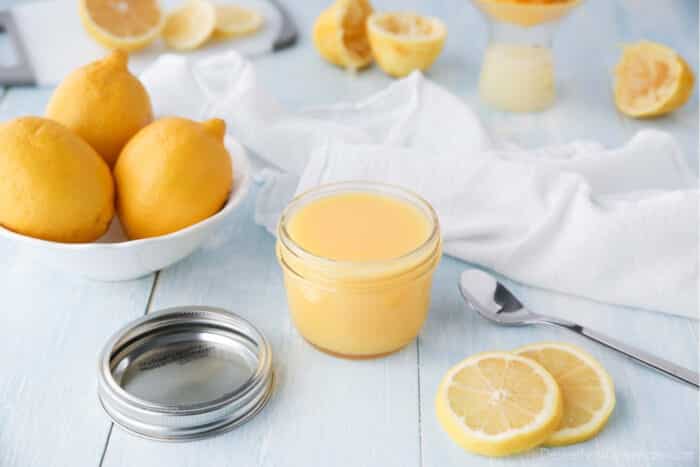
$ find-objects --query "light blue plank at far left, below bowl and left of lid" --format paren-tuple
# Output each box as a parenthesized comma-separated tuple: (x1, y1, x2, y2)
(0, 79, 153, 467)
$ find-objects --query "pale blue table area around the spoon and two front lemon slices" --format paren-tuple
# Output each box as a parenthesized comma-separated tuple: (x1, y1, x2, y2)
(419, 259, 698, 467)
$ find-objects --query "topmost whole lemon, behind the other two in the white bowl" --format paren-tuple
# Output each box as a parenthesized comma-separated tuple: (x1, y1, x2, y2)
(46, 50, 153, 166)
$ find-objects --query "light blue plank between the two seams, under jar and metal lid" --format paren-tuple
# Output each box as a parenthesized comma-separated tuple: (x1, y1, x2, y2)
(103, 188, 419, 467)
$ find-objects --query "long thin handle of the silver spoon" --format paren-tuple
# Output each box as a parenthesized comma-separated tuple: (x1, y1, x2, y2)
(545, 320, 700, 389)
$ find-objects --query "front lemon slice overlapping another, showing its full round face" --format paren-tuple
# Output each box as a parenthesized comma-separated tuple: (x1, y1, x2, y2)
(435, 352, 563, 456)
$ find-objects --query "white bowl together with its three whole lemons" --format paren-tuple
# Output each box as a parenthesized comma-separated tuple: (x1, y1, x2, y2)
(0, 51, 250, 281)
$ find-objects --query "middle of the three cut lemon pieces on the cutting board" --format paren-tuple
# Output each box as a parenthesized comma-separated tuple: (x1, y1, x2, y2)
(163, 0, 216, 50)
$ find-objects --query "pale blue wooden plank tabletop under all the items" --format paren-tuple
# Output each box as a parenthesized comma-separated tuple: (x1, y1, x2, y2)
(0, 0, 698, 467)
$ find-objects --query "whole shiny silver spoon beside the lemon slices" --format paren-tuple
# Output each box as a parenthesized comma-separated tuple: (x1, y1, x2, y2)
(459, 269, 700, 388)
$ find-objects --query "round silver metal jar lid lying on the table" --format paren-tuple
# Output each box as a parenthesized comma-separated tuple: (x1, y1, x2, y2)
(98, 306, 273, 441)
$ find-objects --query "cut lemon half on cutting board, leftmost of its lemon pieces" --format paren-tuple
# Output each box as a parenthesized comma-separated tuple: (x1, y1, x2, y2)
(78, 0, 164, 51)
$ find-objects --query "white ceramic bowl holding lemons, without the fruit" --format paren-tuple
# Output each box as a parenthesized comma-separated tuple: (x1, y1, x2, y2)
(0, 137, 251, 281)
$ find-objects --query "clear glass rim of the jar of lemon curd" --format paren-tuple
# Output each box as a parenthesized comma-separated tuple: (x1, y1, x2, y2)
(277, 180, 440, 268)
